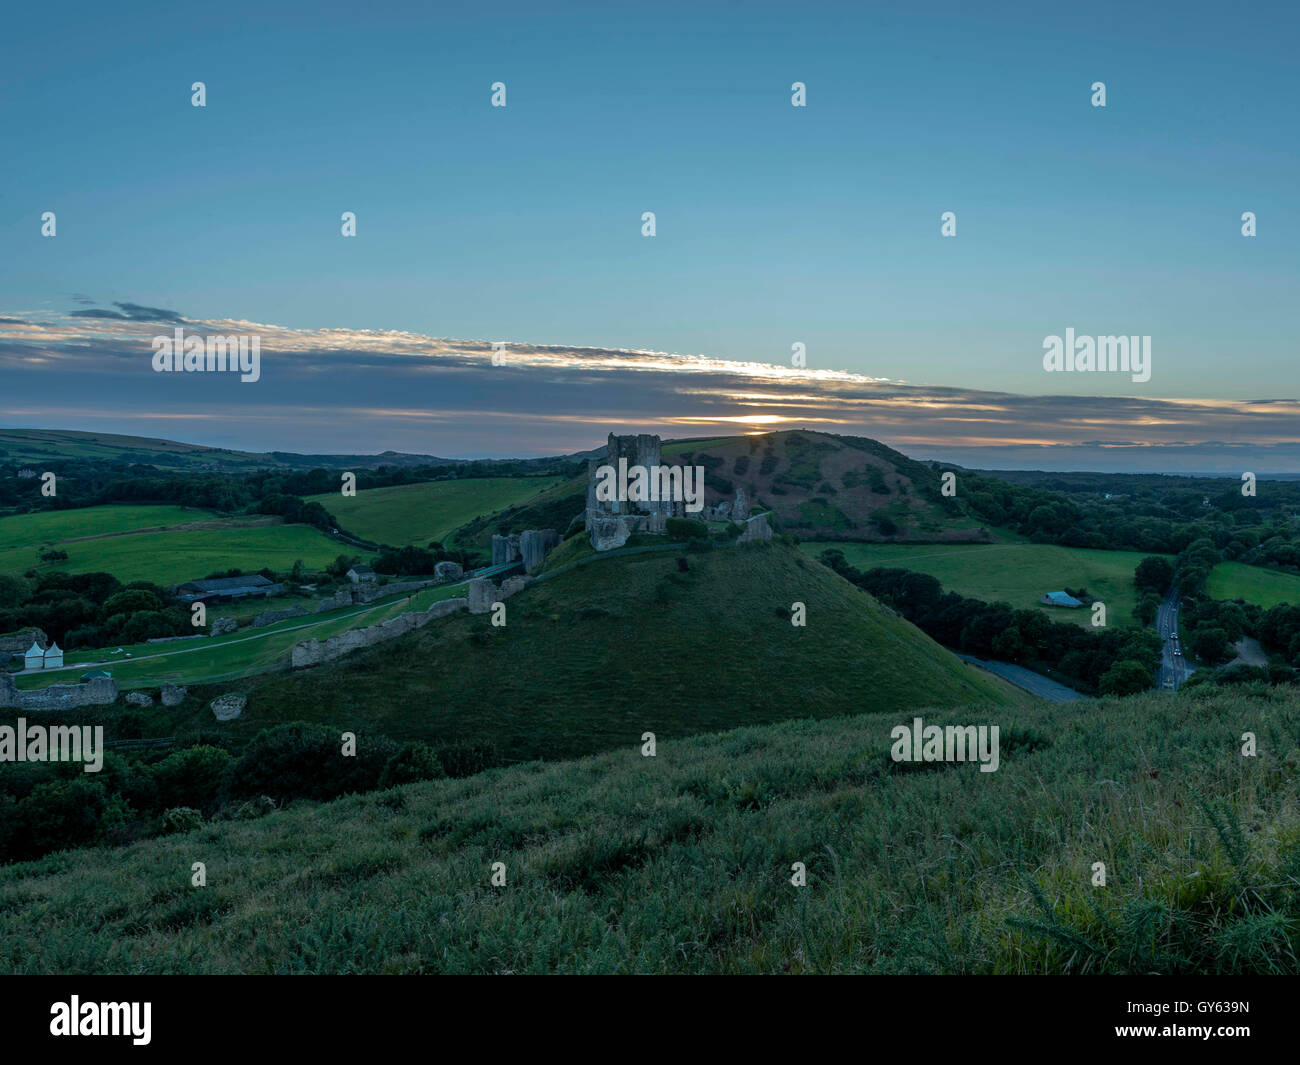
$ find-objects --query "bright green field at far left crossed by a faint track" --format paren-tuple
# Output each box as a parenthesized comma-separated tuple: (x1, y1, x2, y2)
(0, 505, 343, 585)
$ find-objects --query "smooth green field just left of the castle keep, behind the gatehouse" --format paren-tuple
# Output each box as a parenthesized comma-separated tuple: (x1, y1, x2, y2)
(308, 477, 563, 547)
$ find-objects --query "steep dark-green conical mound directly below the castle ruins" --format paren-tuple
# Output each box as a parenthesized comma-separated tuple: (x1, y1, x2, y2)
(210, 544, 1028, 758)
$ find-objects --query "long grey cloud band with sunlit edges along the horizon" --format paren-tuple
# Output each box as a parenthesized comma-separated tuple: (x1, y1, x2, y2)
(0, 310, 1300, 475)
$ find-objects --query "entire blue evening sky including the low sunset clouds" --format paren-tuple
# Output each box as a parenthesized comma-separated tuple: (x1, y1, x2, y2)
(0, 3, 1300, 472)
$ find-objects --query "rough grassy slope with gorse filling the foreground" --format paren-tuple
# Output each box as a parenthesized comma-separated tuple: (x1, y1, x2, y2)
(0, 679, 1300, 974)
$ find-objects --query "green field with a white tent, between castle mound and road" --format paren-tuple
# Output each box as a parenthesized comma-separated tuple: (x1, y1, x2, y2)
(800, 542, 1164, 625)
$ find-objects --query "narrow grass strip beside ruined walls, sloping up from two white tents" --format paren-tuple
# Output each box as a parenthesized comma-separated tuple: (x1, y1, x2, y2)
(16, 584, 465, 690)
